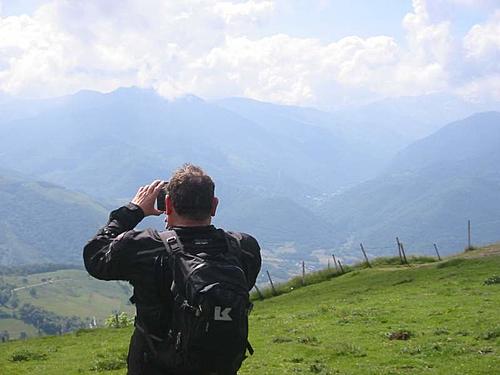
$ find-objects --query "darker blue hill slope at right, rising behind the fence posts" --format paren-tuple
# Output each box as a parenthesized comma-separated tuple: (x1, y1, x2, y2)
(320, 112, 500, 255)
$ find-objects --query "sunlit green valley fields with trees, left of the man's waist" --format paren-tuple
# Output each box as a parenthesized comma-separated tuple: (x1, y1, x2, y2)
(0, 269, 134, 339)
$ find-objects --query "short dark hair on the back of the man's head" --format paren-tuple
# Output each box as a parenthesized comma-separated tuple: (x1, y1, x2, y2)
(167, 164, 215, 220)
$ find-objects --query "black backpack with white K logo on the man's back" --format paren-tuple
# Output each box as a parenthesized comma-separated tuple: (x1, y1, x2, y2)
(152, 230, 253, 375)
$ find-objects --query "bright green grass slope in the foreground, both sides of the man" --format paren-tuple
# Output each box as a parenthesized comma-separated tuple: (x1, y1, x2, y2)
(0, 246, 500, 375)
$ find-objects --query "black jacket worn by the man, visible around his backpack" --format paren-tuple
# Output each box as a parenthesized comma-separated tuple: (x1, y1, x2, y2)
(83, 203, 261, 374)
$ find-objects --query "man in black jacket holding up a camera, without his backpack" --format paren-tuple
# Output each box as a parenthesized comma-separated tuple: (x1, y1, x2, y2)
(83, 164, 261, 375)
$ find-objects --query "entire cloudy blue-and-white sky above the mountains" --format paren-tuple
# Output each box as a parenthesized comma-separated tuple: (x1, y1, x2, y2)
(0, 0, 500, 108)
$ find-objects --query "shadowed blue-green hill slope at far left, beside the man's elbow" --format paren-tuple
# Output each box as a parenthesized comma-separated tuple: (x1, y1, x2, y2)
(0, 169, 107, 265)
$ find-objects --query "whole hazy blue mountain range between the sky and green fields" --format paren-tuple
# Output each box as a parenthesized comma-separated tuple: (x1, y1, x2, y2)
(0, 88, 500, 272)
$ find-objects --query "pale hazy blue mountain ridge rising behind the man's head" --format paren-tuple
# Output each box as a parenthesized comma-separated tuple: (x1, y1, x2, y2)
(0, 88, 408, 260)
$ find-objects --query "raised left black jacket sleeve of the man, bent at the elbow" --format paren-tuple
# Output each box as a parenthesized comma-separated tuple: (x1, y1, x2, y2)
(83, 203, 144, 280)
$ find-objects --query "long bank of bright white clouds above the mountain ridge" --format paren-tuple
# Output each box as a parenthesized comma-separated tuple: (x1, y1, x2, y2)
(0, 0, 500, 106)
